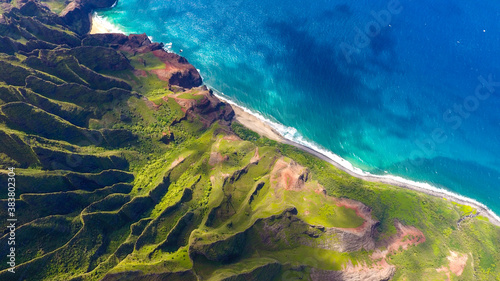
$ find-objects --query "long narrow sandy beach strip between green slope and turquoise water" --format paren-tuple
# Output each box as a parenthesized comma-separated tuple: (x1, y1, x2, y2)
(231, 99, 500, 227)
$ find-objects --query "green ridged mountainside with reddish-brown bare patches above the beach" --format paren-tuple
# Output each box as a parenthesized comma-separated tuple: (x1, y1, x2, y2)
(0, 1, 500, 281)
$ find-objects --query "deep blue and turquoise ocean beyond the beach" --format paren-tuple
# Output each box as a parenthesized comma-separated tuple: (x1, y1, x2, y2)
(99, 0, 500, 214)
